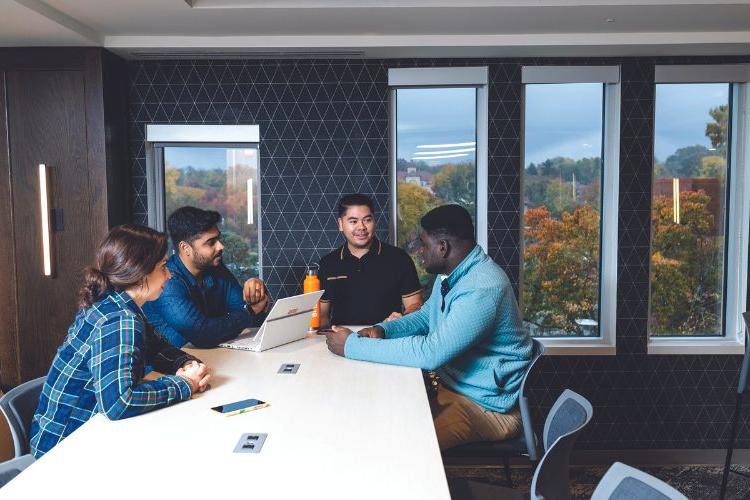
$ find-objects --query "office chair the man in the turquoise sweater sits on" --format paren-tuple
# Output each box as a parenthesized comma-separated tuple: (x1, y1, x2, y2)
(443, 339, 544, 487)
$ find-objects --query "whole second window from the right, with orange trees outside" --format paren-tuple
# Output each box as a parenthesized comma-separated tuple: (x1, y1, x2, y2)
(520, 66, 619, 354)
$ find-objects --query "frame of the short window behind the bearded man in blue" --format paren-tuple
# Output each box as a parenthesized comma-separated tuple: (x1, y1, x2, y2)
(145, 124, 263, 279)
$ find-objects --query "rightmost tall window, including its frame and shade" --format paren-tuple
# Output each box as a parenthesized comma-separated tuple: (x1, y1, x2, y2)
(649, 66, 748, 352)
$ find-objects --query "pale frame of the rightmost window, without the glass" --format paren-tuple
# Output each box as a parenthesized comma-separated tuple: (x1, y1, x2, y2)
(647, 64, 750, 354)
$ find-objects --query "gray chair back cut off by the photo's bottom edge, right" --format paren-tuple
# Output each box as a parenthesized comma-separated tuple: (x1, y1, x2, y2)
(591, 462, 687, 500)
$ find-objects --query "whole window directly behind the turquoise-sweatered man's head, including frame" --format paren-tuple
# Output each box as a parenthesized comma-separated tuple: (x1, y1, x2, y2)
(389, 68, 487, 292)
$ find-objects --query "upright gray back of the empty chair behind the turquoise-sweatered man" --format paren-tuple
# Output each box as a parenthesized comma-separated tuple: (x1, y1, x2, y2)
(531, 389, 594, 500)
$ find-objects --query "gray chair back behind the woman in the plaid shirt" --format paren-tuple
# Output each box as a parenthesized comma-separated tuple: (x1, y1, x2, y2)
(0, 377, 47, 457)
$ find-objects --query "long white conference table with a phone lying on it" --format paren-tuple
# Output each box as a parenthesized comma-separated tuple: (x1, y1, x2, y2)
(0, 336, 450, 500)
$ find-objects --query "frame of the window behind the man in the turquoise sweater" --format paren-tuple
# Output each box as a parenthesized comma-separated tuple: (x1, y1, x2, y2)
(388, 66, 489, 252)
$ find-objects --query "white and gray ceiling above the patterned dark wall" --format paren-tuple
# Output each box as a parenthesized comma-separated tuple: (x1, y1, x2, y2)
(0, 0, 750, 58)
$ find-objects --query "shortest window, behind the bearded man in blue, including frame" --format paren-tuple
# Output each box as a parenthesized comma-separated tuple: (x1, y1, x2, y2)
(147, 125, 261, 283)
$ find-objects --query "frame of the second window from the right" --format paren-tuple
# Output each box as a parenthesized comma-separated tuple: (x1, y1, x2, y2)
(519, 66, 621, 356)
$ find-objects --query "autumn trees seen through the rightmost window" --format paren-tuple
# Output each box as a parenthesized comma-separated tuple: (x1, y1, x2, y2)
(650, 100, 729, 335)
